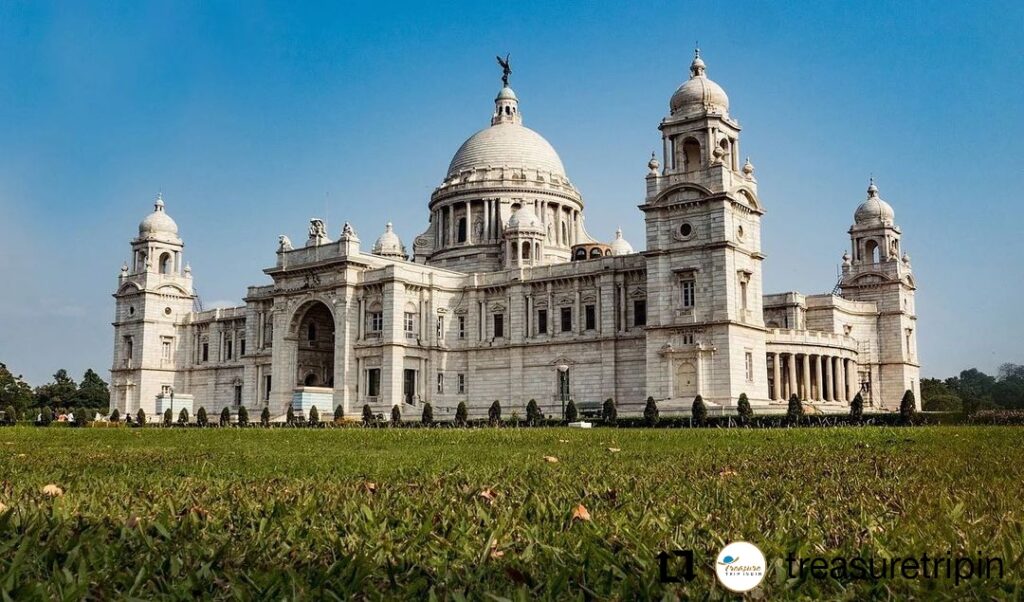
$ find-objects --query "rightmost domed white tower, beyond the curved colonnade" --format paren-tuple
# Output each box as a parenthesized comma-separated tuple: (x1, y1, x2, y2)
(840, 178, 921, 409)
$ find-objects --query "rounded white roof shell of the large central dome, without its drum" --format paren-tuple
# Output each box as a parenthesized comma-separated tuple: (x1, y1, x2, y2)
(446, 123, 565, 178)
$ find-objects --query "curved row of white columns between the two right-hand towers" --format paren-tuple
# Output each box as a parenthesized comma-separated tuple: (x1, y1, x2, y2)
(768, 352, 858, 402)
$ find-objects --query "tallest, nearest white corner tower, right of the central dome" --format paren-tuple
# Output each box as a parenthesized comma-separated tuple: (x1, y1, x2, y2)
(640, 50, 768, 407)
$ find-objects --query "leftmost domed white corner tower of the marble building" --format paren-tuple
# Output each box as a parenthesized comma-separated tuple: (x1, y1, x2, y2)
(111, 195, 196, 417)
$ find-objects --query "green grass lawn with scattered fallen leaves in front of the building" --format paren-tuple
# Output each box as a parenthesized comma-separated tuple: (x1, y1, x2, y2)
(0, 427, 1024, 600)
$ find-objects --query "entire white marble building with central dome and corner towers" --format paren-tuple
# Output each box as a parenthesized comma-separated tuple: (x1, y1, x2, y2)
(112, 50, 920, 420)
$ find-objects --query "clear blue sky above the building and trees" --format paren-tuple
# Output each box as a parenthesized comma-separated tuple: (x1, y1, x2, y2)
(0, 0, 1024, 384)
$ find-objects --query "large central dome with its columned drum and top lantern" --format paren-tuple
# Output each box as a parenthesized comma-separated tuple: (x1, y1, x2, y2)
(413, 59, 593, 272)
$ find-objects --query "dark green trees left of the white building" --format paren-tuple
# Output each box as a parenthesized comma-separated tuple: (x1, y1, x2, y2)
(0, 362, 111, 417)
